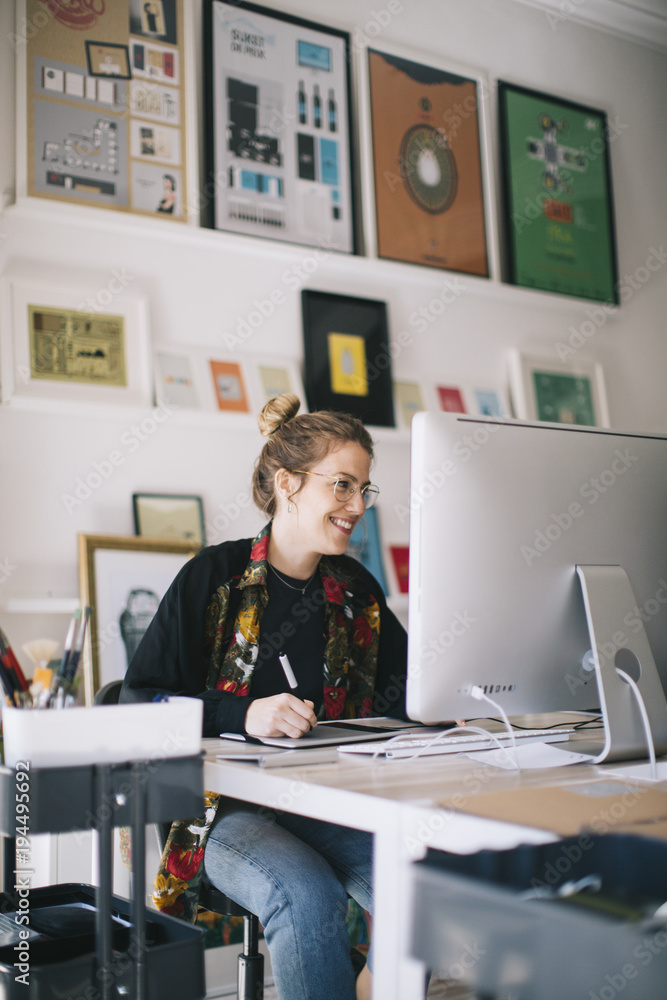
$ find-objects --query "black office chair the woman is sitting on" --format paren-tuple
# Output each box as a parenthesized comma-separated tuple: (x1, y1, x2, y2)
(93, 681, 264, 1000)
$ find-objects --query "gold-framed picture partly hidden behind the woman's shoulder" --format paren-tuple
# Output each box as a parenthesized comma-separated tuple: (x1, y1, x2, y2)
(79, 535, 199, 705)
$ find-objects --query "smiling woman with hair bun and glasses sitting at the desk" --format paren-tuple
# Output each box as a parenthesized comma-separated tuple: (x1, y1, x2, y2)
(123, 395, 407, 1000)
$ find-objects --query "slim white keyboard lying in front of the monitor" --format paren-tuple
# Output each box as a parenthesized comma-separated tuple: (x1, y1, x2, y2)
(338, 726, 576, 759)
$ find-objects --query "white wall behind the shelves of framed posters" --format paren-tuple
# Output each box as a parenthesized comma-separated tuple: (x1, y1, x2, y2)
(0, 0, 667, 672)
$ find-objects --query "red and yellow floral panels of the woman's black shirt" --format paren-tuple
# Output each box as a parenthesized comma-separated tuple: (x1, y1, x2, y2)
(153, 523, 380, 922)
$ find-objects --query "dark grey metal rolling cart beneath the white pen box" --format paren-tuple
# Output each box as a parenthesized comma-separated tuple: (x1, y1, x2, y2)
(0, 754, 206, 1000)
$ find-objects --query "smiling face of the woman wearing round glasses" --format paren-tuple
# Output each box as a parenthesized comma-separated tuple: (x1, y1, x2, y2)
(280, 441, 370, 558)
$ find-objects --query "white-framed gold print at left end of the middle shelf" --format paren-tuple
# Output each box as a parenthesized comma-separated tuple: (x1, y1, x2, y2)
(1, 278, 153, 406)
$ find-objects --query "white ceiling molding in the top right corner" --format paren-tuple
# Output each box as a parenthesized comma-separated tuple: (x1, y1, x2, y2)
(515, 0, 667, 52)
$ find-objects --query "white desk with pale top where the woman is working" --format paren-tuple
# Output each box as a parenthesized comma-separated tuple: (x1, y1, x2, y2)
(204, 722, 598, 1000)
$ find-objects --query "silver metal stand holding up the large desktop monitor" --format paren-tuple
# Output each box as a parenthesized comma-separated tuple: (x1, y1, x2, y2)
(567, 566, 667, 764)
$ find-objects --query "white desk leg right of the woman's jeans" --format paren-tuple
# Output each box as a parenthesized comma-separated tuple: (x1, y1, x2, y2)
(373, 810, 424, 1000)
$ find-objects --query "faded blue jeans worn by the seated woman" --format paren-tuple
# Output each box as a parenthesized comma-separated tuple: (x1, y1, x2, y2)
(204, 800, 373, 1000)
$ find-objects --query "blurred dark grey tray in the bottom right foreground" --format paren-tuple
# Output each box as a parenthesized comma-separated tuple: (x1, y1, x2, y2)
(411, 834, 667, 1000)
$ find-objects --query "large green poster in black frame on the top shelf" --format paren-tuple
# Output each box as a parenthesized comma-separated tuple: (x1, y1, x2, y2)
(498, 81, 619, 304)
